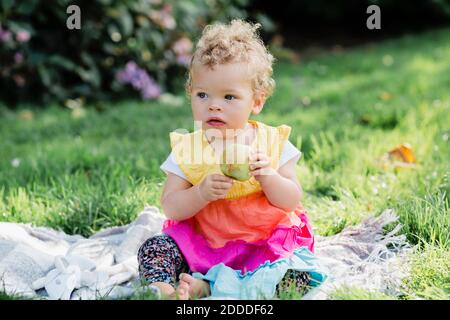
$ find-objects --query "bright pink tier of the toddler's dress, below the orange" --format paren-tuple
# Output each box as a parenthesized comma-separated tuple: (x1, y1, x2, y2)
(162, 199, 314, 273)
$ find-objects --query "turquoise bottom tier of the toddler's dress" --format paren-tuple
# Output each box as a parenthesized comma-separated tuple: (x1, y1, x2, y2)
(192, 247, 327, 300)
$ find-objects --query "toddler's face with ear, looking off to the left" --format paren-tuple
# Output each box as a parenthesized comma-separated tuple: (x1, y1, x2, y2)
(191, 63, 264, 138)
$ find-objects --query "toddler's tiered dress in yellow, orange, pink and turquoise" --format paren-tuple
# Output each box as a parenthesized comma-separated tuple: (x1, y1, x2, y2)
(163, 121, 324, 295)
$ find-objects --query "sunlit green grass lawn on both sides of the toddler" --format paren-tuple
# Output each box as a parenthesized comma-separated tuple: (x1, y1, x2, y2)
(0, 28, 450, 299)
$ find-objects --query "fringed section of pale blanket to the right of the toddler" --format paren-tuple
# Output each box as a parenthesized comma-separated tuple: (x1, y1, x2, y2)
(303, 209, 413, 300)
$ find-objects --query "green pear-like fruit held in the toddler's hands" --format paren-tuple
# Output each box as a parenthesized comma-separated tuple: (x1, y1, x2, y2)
(220, 143, 252, 181)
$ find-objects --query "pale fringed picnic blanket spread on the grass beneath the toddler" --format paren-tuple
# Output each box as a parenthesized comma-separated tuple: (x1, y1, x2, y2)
(0, 206, 411, 300)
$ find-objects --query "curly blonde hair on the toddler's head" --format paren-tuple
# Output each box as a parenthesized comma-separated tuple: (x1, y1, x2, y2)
(185, 19, 275, 98)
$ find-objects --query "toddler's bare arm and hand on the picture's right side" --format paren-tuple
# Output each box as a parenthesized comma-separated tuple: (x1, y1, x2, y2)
(251, 153, 302, 211)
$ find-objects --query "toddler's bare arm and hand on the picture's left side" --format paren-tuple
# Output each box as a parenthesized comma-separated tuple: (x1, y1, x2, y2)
(161, 173, 233, 220)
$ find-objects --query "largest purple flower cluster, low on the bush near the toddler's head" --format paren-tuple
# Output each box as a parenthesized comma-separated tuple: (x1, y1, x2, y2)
(116, 61, 161, 99)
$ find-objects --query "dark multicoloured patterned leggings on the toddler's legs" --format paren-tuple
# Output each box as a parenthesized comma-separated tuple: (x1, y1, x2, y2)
(137, 235, 311, 294)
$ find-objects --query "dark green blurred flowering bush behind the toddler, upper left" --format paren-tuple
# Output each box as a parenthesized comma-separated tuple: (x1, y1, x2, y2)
(0, 0, 247, 103)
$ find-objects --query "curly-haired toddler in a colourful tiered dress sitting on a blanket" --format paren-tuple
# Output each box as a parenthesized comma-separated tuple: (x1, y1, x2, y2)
(138, 20, 323, 299)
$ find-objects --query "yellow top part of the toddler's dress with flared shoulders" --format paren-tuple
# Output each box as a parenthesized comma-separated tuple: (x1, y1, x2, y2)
(170, 120, 291, 199)
